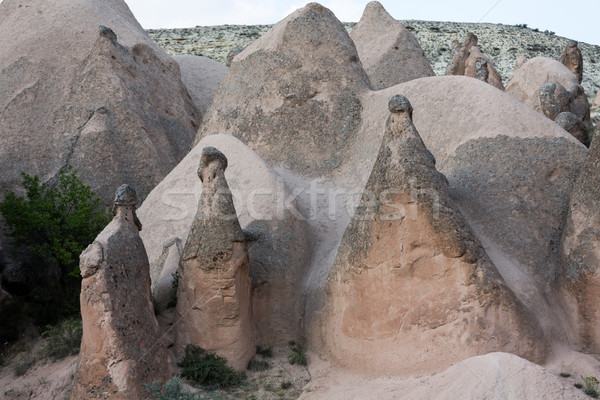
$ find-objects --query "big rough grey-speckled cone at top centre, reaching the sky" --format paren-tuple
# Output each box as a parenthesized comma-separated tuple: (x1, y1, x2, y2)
(199, 3, 370, 176)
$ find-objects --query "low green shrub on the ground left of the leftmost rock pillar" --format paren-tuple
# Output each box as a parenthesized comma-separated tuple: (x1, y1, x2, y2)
(40, 319, 83, 360)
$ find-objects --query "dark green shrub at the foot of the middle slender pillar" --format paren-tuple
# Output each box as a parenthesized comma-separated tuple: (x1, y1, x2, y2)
(177, 344, 244, 387)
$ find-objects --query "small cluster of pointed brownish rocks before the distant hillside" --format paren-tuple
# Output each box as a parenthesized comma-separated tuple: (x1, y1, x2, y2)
(446, 32, 504, 90)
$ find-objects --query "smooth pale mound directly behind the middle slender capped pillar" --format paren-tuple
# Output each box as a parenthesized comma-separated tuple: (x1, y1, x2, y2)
(138, 135, 310, 346)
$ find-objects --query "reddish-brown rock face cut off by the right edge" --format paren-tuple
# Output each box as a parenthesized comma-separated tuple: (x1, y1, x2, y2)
(559, 127, 600, 353)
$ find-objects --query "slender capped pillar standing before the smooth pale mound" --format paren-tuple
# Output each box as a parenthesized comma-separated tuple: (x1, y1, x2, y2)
(176, 147, 256, 371)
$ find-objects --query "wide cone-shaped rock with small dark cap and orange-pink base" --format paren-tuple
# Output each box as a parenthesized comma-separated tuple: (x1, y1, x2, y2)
(318, 95, 546, 373)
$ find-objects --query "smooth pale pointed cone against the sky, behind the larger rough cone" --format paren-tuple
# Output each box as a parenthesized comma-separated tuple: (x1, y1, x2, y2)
(350, 1, 435, 90)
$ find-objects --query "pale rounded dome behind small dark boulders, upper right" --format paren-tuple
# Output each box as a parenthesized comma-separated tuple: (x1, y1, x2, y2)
(506, 57, 590, 122)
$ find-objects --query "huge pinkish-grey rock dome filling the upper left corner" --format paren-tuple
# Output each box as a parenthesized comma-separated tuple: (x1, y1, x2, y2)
(0, 0, 200, 205)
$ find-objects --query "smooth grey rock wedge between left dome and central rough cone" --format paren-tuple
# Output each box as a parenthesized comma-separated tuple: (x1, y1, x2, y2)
(173, 54, 228, 115)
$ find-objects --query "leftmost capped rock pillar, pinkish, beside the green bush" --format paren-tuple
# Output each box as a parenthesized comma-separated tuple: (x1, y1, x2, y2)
(71, 185, 173, 400)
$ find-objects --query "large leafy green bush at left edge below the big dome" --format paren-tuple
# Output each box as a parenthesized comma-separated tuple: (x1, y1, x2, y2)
(0, 167, 110, 326)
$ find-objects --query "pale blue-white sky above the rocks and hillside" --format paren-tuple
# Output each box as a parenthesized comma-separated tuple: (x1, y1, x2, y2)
(120, 0, 600, 45)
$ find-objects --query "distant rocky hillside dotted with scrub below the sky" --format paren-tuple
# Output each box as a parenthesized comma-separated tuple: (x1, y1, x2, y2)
(148, 20, 600, 101)
